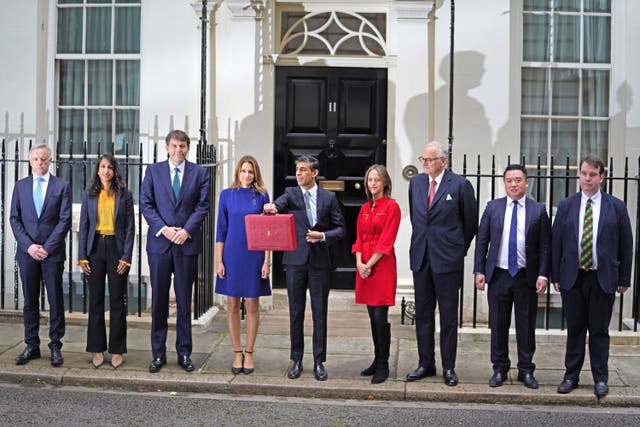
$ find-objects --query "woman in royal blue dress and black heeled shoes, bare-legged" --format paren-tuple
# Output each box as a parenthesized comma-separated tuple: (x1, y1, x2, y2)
(216, 156, 271, 374)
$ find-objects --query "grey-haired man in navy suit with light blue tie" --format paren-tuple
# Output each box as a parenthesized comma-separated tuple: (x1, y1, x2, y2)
(9, 144, 71, 366)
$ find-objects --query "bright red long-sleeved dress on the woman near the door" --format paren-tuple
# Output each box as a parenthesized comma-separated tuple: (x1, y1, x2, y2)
(351, 196, 400, 305)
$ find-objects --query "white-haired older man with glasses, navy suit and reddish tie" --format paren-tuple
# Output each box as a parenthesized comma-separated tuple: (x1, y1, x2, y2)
(407, 141, 478, 386)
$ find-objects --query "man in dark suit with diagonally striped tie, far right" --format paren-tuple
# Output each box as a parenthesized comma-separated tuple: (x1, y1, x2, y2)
(551, 156, 633, 397)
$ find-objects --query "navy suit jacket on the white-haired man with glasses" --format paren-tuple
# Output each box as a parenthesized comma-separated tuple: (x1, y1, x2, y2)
(409, 170, 478, 274)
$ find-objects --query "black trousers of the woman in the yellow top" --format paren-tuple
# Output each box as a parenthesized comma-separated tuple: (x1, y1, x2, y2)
(86, 234, 129, 354)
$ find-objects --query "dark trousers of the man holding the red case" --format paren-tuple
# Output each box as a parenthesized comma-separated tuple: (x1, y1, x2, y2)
(286, 265, 329, 363)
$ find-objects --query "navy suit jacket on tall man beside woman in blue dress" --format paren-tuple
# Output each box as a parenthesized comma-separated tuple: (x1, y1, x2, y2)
(140, 160, 209, 255)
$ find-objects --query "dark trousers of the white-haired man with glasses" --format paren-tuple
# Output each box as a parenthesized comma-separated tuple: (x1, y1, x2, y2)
(413, 264, 462, 370)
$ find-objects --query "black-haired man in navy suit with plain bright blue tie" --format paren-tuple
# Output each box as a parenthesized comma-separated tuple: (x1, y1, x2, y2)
(474, 165, 551, 389)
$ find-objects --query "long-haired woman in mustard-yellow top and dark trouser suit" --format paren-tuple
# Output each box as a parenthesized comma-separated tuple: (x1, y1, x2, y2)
(78, 154, 135, 368)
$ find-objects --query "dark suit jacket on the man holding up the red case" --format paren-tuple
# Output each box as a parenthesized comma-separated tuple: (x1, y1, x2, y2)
(273, 187, 345, 268)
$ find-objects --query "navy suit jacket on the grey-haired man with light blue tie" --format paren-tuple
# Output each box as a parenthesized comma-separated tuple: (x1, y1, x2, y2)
(9, 175, 71, 262)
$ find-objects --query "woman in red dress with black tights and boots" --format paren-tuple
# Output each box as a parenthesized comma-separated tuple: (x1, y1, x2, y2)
(351, 165, 400, 384)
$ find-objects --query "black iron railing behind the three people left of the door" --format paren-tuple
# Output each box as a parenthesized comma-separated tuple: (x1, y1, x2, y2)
(0, 139, 217, 318)
